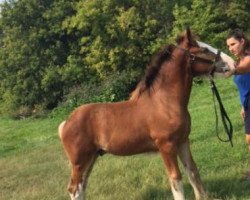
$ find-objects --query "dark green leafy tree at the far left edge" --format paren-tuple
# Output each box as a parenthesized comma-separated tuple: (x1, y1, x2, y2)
(0, 0, 76, 110)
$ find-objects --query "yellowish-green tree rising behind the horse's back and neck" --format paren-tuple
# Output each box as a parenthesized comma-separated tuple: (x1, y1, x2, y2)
(65, 0, 176, 78)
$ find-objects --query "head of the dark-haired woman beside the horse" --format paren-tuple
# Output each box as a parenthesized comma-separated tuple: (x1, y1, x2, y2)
(227, 29, 250, 57)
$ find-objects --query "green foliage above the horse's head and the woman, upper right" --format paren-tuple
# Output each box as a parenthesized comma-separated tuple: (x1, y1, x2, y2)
(172, 0, 250, 50)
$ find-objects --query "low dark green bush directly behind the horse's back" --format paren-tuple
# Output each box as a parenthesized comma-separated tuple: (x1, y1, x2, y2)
(54, 70, 139, 115)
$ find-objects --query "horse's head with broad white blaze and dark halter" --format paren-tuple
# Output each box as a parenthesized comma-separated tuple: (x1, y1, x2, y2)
(177, 28, 229, 76)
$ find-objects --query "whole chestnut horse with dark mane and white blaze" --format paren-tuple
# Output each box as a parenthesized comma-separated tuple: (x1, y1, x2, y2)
(59, 29, 227, 200)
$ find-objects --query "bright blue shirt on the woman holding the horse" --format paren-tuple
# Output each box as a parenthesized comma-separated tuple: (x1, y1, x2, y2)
(234, 73, 250, 109)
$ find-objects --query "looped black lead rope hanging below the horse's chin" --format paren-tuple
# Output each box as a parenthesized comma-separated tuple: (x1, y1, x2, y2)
(209, 75, 233, 147)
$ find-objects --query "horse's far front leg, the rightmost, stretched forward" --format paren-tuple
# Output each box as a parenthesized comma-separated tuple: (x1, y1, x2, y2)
(179, 140, 208, 200)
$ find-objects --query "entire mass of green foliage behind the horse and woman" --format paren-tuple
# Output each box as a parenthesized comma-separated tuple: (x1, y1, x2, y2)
(0, 0, 250, 113)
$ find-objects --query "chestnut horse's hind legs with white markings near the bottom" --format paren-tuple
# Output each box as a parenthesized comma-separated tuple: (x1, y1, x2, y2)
(68, 154, 97, 200)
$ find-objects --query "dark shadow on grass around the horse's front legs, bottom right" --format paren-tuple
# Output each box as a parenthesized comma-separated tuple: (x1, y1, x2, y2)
(140, 178, 250, 200)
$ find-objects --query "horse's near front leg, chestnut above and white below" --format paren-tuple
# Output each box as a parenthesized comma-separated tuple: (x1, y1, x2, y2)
(158, 142, 185, 200)
